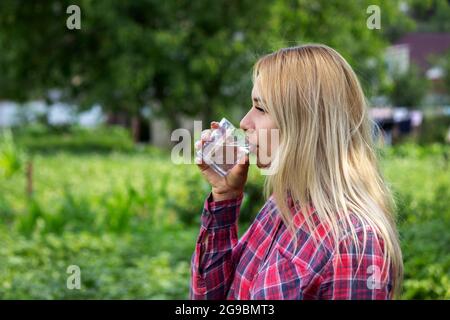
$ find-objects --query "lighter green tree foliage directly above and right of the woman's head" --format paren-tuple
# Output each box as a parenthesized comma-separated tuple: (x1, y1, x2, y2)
(270, 0, 414, 95)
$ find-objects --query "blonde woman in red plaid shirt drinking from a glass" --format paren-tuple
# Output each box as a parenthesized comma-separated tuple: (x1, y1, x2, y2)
(190, 45, 403, 299)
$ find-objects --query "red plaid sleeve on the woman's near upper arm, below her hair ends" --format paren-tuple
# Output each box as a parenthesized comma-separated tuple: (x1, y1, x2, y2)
(319, 231, 392, 300)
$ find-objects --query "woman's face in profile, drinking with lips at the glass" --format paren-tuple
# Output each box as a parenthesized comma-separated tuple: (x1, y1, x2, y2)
(240, 80, 279, 168)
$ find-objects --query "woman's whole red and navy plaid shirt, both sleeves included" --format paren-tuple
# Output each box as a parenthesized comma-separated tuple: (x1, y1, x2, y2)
(190, 194, 392, 300)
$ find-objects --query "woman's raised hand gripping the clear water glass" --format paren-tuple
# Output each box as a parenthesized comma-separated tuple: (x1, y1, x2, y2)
(195, 121, 249, 201)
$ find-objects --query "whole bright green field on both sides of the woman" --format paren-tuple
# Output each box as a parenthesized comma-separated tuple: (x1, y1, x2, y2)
(0, 141, 450, 299)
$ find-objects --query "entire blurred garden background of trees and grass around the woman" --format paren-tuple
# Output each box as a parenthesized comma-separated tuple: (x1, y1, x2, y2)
(0, 0, 450, 299)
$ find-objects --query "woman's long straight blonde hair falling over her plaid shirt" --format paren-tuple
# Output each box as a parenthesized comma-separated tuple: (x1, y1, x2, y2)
(253, 44, 403, 297)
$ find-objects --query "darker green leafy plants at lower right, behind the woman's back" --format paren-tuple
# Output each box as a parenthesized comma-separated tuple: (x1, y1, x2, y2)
(390, 175, 450, 299)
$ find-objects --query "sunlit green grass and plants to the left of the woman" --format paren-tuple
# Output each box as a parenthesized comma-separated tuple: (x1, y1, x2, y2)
(0, 152, 200, 299)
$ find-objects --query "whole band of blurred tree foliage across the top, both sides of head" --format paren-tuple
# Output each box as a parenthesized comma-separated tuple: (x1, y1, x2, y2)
(0, 0, 412, 126)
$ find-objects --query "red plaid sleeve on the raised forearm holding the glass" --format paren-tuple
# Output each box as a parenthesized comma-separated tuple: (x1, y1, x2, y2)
(189, 194, 243, 300)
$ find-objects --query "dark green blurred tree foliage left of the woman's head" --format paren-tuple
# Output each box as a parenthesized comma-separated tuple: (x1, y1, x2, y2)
(0, 0, 268, 136)
